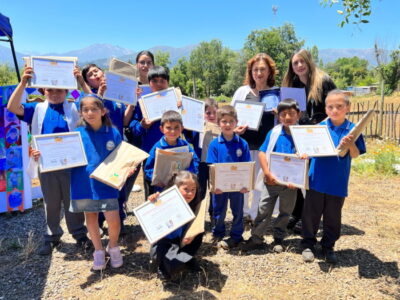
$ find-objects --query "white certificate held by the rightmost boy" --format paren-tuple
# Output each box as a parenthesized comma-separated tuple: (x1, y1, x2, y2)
(289, 125, 338, 157)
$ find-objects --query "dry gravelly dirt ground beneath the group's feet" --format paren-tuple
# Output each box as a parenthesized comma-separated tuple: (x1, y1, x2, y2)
(0, 174, 400, 300)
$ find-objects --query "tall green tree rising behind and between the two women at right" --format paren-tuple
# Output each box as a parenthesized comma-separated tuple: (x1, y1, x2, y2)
(243, 23, 304, 84)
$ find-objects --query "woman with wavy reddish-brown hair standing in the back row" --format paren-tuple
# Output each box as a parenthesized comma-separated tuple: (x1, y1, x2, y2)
(231, 53, 277, 220)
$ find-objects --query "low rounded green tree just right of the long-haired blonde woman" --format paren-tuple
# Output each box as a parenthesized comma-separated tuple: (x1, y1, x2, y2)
(325, 56, 373, 89)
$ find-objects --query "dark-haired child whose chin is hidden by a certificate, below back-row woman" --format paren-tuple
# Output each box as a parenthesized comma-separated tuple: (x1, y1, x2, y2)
(129, 66, 175, 199)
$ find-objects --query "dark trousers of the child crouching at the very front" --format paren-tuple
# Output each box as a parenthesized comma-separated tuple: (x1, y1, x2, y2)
(150, 233, 203, 276)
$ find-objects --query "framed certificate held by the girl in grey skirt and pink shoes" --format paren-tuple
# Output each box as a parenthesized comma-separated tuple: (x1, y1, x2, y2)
(32, 131, 87, 173)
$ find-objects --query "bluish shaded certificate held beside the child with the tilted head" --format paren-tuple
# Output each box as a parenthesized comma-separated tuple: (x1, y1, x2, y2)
(104, 72, 138, 105)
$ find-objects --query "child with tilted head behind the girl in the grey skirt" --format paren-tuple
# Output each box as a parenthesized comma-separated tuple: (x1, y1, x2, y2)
(81, 64, 133, 235)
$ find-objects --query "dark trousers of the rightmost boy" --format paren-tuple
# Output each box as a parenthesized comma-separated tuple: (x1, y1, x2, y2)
(301, 189, 345, 249)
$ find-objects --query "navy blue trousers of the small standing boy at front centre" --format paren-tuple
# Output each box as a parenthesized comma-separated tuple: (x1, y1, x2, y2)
(211, 192, 244, 242)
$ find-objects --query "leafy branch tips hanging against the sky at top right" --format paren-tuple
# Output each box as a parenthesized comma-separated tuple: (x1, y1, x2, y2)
(321, 0, 372, 27)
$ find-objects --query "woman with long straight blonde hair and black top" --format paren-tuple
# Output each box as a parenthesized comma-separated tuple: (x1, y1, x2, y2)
(282, 49, 336, 124)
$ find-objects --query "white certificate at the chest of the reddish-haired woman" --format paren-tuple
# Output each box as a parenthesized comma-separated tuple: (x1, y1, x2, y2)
(234, 101, 265, 131)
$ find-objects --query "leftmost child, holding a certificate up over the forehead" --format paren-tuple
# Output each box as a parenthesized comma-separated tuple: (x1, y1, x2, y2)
(7, 67, 91, 255)
